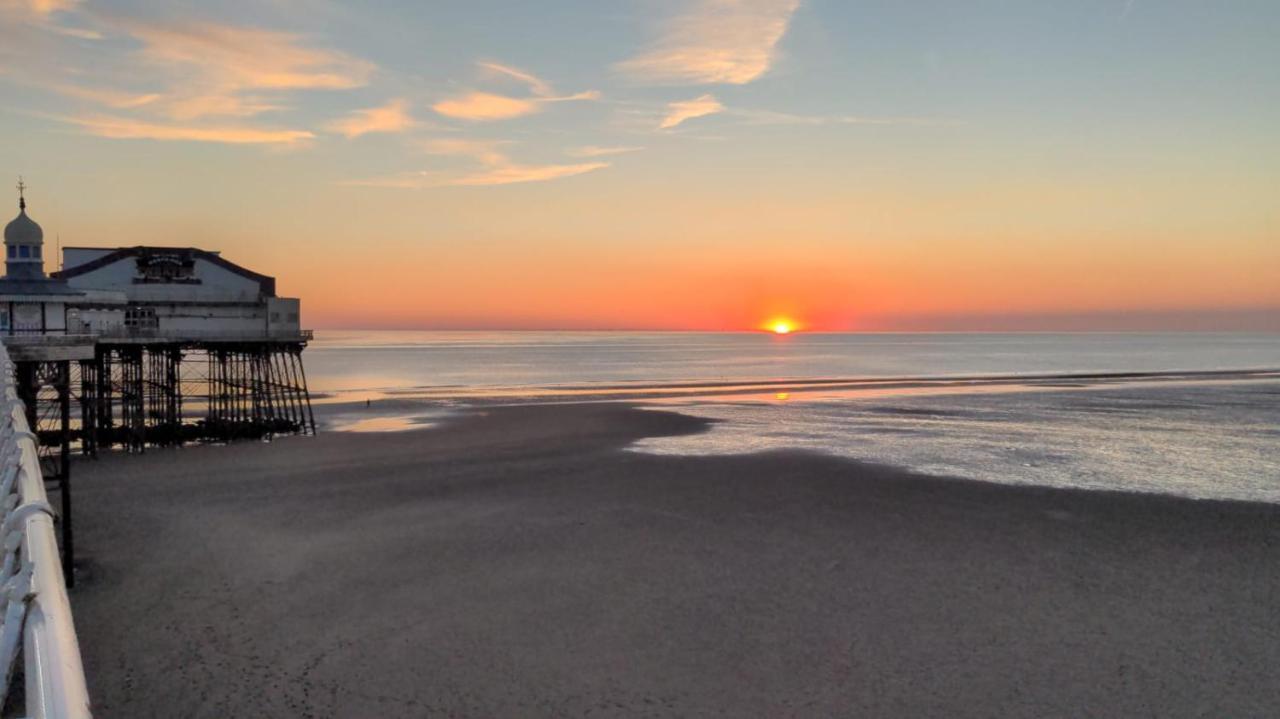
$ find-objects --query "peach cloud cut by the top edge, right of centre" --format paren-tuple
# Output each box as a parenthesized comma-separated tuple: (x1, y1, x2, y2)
(617, 0, 800, 84)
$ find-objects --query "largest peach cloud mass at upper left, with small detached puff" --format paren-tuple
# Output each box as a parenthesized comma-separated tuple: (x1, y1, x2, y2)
(22, 12, 376, 146)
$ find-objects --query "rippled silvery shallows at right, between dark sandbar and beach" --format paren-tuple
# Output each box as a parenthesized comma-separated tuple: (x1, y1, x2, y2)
(634, 379, 1280, 503)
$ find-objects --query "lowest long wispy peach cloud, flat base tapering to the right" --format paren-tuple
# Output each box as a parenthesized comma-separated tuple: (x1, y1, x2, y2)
(347, 139, 609, 188)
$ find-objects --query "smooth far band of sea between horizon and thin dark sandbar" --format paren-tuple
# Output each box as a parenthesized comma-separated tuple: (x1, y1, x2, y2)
(306, 331, 1280, 399)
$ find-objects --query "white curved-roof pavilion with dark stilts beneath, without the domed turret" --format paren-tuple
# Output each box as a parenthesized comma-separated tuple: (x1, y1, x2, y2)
(52, 246, 315, 453)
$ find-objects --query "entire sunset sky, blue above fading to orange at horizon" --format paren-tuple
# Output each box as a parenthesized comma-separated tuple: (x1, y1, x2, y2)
(0, 0, 1280, 331)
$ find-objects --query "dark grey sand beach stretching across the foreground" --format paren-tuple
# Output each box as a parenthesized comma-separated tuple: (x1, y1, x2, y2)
(72, 404, 1280, 718)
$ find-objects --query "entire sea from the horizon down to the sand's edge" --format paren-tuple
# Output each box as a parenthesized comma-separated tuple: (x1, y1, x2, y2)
(303, 330, 1280, 503)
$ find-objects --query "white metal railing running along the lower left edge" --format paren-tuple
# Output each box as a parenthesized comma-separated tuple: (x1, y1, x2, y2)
(0, 344, 92, 719)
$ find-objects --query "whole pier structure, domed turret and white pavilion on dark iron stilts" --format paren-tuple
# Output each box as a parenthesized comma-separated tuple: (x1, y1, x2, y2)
(0, 188, 315, 460)
